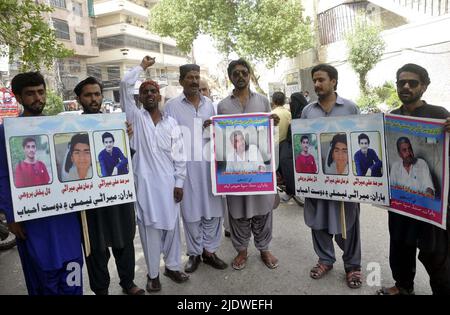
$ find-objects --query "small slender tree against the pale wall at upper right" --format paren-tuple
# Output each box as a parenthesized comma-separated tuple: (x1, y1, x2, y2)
(346, 17, 385, 97)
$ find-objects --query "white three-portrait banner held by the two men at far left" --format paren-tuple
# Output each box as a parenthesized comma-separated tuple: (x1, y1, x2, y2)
(4, 114, 136, 222)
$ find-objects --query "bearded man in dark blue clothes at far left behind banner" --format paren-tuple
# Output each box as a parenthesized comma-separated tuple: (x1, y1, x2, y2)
(0, 72, 83, 295)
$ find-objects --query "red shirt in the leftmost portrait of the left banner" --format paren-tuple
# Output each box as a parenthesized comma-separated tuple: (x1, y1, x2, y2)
(14, 161, 50, 188)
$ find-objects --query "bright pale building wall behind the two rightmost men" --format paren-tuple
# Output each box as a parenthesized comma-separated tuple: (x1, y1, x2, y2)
(276, 0, 450, 109)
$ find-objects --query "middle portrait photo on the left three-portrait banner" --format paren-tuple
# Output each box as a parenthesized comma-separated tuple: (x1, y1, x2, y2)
(53, 132, 92, 182)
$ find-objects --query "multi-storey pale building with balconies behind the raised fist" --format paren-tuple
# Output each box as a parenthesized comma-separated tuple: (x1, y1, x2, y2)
(87, 0, 189, 102)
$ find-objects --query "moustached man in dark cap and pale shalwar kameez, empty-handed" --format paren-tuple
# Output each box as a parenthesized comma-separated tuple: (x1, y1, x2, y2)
(164, 64, 227, 273)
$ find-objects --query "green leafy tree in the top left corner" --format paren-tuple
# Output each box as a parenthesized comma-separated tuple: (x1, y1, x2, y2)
(0, 0, 73, 71)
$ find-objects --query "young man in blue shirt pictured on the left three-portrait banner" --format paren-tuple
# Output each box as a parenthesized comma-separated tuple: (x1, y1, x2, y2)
(98, 132, 128, 177)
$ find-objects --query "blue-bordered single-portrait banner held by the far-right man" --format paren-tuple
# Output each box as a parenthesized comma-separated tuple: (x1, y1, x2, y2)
(386, 115, 448, 224)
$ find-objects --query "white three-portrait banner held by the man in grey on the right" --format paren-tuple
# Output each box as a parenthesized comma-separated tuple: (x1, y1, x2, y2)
(291, 114, 389, 205)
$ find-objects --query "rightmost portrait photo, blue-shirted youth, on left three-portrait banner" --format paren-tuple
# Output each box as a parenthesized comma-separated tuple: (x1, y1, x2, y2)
(93, 130, 129, 177)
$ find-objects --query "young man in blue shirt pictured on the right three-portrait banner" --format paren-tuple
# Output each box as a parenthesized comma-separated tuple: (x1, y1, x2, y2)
(355, 133, 383, 177)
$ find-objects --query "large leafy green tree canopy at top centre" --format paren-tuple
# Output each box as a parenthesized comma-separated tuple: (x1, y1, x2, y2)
(149, 0, 313, 92)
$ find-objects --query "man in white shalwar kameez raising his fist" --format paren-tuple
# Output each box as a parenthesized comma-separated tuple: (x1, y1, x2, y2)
(120, 56, 189, 292)
